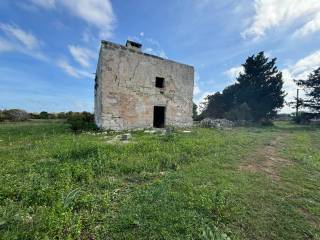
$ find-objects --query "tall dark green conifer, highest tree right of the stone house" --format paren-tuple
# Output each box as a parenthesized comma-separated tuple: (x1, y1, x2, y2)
(234, 52, 285, 121)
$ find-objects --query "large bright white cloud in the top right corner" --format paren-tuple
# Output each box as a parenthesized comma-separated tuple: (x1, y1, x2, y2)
(242, 0, 320, 39)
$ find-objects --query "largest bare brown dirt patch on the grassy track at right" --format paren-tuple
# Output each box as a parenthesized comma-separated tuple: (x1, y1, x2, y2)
(239, 135, 291, 181)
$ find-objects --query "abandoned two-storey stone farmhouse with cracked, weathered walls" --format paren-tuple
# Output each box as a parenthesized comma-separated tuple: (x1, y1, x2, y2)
(94, 41, 194, 130)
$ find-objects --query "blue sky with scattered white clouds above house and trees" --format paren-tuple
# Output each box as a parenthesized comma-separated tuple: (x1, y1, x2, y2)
(0, 0, 320, 112)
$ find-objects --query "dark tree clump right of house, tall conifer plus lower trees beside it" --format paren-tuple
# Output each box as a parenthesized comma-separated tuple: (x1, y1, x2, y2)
(201, 52, 285, 122)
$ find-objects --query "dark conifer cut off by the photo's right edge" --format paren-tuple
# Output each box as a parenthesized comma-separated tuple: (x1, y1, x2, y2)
(296, 67, 320, 113)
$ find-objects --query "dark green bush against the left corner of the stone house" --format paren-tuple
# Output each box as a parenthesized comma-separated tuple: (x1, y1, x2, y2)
(67, 112, 98, 132)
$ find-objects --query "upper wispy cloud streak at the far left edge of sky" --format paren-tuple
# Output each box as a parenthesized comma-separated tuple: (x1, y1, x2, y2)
(0, 23, 40, 50)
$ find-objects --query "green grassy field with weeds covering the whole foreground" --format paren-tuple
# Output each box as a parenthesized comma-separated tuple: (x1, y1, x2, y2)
(0, 122, 320, 240)
